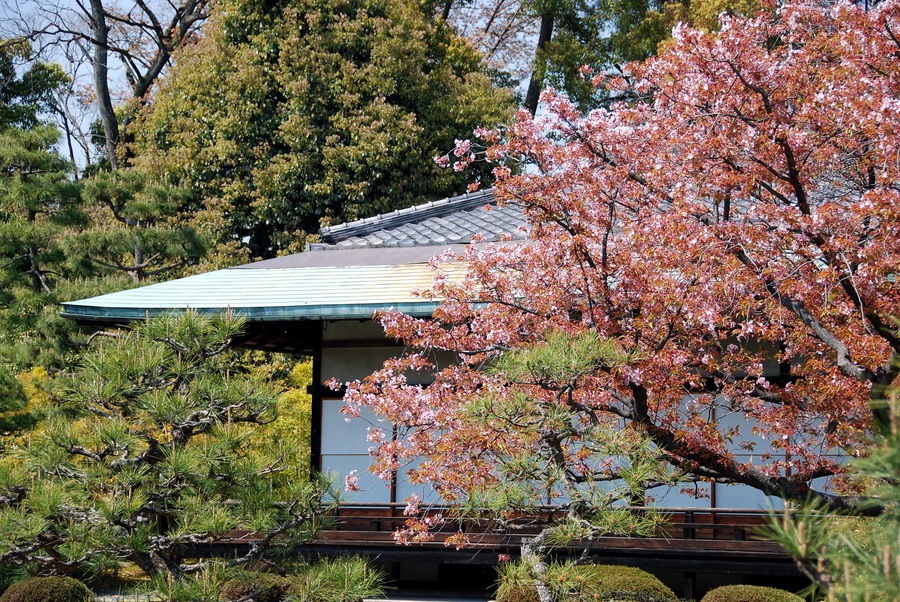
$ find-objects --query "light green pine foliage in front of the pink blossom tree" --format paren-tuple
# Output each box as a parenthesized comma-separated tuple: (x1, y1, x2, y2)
(465, 332, 679, 545)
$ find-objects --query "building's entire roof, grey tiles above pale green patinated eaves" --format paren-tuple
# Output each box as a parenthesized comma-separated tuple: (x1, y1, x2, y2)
(63, 191, 524, 322)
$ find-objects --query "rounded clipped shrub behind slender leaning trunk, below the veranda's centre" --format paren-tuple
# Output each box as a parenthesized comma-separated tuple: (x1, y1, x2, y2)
(497, 561, 678, 602)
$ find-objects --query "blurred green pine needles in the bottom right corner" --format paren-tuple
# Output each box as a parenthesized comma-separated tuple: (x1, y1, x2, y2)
(767, 378, 900, 602)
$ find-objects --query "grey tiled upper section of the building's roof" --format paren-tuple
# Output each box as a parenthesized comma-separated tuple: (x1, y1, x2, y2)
(309, 190, 526, 251)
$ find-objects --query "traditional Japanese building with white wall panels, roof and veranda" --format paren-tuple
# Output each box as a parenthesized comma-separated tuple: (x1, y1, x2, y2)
(64, 191, 795, 591)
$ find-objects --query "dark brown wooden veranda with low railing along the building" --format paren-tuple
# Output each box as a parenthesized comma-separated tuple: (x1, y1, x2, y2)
(191, 503, 801, 599)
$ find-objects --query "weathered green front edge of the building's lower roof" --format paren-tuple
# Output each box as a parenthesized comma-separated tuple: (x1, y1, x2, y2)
(62, 301, 440, 322)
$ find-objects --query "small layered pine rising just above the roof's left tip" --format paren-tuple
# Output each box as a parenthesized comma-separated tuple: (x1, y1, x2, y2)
(67, 170, 206, 283)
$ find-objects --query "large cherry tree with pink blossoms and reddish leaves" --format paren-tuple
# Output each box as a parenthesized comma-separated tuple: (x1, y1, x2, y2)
(347, 1, 900, 520)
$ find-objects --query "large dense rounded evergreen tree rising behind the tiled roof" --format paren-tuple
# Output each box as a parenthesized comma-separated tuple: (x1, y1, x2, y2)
(134, 0, 512, 256)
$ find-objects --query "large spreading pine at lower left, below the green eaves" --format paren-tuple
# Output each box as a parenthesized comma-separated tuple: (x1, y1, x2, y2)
(0, 314, 336, 578)
